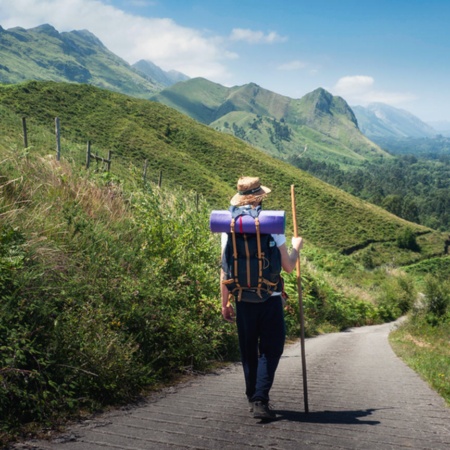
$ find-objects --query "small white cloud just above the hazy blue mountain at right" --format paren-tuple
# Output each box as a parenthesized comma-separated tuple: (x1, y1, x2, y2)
(331, 75, 417, 106)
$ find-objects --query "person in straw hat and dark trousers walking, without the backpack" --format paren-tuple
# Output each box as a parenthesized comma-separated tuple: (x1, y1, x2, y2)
(221, 177, 303, 420)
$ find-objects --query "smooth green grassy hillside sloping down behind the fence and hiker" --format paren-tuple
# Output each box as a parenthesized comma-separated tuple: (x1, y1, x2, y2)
(0, 82, 440, 260)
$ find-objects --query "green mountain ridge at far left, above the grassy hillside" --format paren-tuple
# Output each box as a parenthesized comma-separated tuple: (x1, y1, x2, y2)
(0, 24, 163, 98)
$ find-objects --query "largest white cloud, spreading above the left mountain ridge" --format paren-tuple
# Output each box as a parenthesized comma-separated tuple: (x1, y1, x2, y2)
(0, 0, 237, 81)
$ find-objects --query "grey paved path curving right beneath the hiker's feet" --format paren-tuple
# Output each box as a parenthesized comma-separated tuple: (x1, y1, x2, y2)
(12, 324, 450, 450)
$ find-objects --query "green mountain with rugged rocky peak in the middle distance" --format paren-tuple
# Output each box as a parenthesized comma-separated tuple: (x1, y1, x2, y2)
(151, 78, 390, 166)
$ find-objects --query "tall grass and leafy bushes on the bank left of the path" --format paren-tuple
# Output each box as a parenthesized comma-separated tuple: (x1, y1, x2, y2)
(0, 150, 237, 442)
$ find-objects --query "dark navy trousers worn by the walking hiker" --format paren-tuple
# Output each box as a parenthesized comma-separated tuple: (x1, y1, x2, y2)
(236, 296, 286, 402)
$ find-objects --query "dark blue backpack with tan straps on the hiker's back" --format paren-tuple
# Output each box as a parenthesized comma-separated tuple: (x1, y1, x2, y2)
(222, 206, 282, 303)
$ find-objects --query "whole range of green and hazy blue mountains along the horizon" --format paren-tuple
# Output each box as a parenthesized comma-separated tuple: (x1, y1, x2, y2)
(0, 24, 437, 166)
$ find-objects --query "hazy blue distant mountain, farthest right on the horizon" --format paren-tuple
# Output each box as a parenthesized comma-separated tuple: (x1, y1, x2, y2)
(352, 103, 438, 142)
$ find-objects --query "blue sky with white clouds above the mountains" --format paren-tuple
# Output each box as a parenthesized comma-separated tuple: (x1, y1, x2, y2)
(0, 0, 450, 122)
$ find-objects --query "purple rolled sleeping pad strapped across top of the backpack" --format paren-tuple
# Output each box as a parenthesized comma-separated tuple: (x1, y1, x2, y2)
(209, 210, 286, 234)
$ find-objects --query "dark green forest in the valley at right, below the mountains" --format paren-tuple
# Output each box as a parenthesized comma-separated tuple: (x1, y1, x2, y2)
(289, 152, 450, 231)
